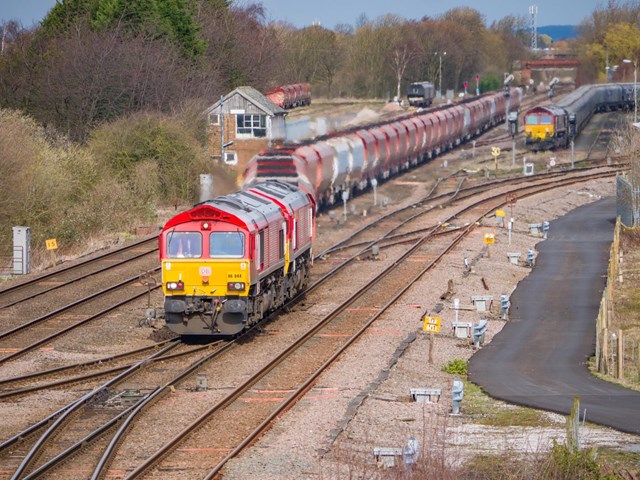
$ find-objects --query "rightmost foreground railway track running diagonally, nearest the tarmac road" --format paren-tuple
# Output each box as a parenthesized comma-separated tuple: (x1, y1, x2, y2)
(63, 167, 612, 478)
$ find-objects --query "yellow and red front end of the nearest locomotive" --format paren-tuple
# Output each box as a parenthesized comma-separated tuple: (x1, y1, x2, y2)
(160, 210, 251, 335)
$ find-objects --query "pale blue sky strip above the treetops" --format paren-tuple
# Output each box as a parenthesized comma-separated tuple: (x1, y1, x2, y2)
(0, 0, 604, 28)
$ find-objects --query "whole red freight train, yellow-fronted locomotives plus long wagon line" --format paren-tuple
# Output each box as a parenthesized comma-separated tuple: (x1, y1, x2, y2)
(159, 89, 522, 337)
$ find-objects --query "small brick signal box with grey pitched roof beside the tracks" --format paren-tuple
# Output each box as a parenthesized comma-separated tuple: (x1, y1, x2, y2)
(205, 87, 287, 180)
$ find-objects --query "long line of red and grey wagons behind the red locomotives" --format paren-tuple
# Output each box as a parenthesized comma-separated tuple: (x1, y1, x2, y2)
(243, 88, 522, 208)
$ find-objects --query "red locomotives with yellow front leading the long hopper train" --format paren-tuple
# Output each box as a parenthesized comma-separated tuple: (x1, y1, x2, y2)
(159, 180, 315, 336)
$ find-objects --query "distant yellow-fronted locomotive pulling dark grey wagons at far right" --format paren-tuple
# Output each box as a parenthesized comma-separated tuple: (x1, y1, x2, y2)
(524, 83, 634, 151)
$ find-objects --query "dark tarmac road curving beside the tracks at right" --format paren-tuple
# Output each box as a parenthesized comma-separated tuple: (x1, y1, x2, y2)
(469, 197, 640, 434)
